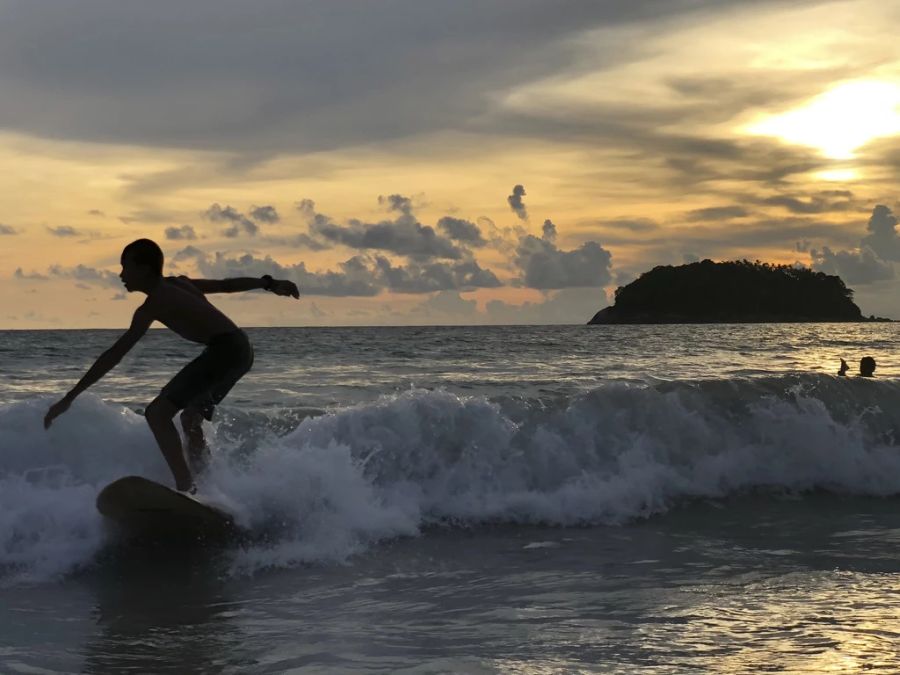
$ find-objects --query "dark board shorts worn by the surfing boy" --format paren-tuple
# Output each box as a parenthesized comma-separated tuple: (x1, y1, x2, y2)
(160, 330, 253, 420)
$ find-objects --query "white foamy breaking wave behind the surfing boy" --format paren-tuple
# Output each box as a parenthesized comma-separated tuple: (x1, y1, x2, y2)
(0, 377, 900, 579)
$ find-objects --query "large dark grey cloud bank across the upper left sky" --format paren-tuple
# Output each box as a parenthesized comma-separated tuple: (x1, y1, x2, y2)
(0, 0, 728, 155)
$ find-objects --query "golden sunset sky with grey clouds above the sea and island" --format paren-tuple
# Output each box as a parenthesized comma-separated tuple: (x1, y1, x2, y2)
(0, 0, 900, 329)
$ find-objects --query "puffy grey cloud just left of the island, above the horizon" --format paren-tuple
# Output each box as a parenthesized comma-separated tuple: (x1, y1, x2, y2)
(515, 235, 612, 290)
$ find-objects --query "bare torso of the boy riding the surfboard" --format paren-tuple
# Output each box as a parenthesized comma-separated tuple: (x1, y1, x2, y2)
(138, 277, 237, 344)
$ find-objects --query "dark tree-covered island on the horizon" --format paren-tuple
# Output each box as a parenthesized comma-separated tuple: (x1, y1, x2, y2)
(588, 260, 890, 324)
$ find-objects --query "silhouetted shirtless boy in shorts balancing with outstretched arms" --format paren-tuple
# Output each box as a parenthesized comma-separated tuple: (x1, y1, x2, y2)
(44, 239, 300, 492)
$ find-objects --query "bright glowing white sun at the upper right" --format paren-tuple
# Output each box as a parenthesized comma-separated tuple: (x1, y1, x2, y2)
(745, 80, 900, 159)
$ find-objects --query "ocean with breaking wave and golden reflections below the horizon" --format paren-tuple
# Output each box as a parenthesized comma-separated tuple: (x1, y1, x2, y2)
(0, 323, 900, 674)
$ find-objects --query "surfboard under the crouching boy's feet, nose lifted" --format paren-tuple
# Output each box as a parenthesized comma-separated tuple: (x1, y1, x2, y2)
(97, 476, 238, 538)
